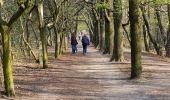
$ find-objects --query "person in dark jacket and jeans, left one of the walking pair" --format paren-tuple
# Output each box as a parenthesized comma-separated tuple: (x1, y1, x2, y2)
(71, 34, 78, 54)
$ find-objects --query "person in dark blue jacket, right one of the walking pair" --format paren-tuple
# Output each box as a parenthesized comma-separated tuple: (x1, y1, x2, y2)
(81, 34, 90, 55)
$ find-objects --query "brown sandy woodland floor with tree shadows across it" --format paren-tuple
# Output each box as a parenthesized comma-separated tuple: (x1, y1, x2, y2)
(2, 41, 170, 100)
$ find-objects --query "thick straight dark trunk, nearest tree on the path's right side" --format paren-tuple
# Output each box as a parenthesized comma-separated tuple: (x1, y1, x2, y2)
(129, 0, 142, 79)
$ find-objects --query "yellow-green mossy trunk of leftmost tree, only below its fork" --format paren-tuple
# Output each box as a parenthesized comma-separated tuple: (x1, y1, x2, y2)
(0, 25, 15, 97)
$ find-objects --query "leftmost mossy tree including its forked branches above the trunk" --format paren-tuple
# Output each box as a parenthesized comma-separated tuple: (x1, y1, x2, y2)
(0, 0, 32, 97)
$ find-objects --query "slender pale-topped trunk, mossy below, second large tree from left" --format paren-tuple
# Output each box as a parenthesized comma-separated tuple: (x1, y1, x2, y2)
(38, 0, 48, 68)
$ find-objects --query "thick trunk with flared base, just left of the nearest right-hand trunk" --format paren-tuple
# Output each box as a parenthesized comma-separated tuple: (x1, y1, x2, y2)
(111, 0, 124, 61)
